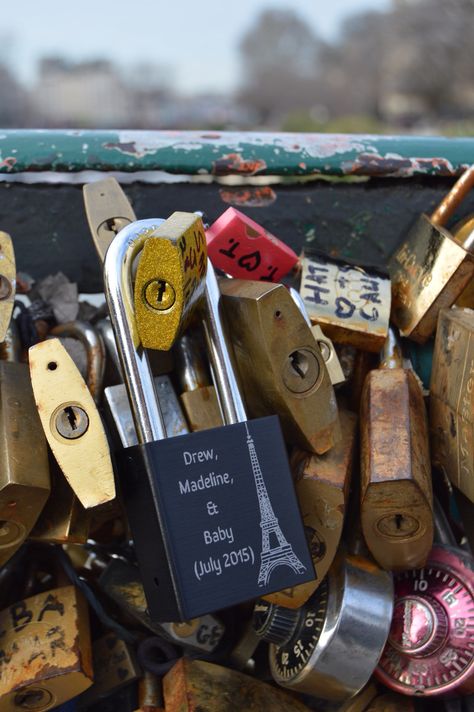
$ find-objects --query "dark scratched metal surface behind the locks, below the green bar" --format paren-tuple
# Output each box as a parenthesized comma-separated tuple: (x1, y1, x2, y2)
(0, 176, 474, 292)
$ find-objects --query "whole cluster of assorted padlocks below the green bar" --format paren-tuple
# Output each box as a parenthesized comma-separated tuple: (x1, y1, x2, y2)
(0, 164, 474, 712)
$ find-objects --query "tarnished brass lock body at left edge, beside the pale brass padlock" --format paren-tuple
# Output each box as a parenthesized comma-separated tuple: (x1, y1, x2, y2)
(0, 361, 51, 565)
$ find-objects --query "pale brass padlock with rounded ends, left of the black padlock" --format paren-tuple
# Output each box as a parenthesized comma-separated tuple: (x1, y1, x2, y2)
(29, 339, 115, 508)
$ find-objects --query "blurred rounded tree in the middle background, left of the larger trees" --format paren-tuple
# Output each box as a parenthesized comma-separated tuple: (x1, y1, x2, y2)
(239, 9, 323, 125)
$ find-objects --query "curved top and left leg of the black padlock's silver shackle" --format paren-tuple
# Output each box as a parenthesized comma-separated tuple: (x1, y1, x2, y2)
(104, 218, 166, 444)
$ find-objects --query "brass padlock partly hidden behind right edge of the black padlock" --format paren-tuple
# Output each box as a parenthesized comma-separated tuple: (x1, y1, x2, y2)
(264, 410, 357, 608)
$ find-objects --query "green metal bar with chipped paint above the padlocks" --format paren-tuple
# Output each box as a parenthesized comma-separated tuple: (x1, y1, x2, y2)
(0, 130, 474, 177)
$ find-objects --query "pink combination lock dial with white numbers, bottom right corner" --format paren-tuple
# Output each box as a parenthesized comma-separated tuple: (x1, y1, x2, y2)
(376, 547, 474, 695)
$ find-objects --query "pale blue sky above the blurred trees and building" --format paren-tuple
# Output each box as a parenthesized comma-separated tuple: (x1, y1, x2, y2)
(0, 0, 391, 92)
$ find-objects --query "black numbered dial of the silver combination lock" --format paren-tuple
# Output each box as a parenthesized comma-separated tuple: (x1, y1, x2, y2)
(270, 579, 328, 684)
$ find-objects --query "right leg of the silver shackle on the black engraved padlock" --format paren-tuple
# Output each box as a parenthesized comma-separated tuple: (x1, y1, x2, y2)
(203, 258, 247, 425)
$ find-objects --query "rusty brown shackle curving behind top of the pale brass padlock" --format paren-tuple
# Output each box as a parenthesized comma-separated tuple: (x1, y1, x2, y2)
(50, 319, 105, 403)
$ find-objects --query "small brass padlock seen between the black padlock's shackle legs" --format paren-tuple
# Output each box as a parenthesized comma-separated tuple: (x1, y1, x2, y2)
(174, 333, 223, 432)
